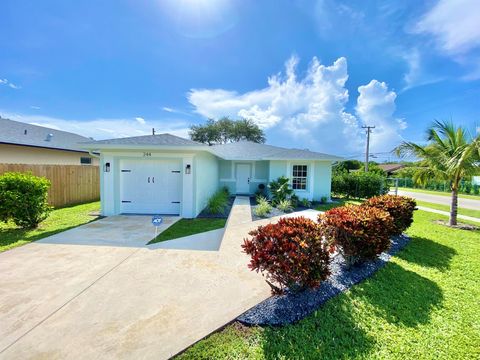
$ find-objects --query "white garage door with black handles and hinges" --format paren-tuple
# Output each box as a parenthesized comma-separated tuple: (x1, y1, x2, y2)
(120, 159, 182, 215)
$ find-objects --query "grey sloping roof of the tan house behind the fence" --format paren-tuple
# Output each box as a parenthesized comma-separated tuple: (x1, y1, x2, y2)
(0, 117, 91, 152)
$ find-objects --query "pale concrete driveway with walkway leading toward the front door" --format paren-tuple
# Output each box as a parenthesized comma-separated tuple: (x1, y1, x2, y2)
(0, 203, 270, 359)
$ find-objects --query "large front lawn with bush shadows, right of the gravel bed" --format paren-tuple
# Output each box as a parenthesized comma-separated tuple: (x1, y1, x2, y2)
(176, 211, 480, 360)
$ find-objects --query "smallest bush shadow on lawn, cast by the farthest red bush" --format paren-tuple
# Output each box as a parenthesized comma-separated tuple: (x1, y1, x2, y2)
(396, 236, 457, 271)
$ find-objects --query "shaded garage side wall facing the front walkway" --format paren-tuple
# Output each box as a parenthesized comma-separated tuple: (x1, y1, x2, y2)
(193, 151, 219, 216)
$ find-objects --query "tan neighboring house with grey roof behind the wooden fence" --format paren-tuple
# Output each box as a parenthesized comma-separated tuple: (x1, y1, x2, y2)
(0, 118, 98, 165)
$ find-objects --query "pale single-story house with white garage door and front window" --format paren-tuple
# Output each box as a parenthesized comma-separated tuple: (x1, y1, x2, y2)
(84, 134, 341, 218)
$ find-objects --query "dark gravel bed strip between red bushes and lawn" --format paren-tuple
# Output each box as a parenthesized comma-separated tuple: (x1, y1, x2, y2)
(237, 235, 410, 326)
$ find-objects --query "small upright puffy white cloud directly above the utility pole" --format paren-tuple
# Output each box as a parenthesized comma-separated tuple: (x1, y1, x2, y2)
(356, 80, 407, 152)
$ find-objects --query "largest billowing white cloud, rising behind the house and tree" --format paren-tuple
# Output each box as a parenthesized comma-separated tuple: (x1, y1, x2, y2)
(188, 56, 400, 154)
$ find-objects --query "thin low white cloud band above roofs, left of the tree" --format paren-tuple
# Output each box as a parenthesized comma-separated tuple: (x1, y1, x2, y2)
(0, 110, 188, 140)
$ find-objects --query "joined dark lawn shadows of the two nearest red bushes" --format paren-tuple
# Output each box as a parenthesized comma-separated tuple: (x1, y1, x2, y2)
(262, 260, 443, 359)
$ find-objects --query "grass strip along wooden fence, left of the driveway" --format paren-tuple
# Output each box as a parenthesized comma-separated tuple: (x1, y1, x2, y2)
(0, 201, 100, 252)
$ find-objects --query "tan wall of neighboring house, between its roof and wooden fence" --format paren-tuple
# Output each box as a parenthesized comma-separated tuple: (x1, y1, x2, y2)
(0, 144, 99, 166)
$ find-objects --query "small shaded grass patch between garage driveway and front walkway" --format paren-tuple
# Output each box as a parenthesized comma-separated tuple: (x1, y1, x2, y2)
(149, 218, 227, 244)
